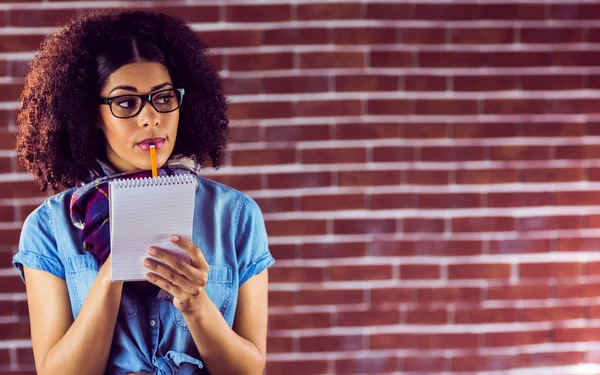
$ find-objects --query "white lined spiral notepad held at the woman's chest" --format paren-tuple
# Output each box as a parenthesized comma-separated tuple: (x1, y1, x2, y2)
(108, 175, 197, 281)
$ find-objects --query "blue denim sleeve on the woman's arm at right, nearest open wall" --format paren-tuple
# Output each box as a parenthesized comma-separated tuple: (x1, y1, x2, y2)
(235, 195, 275, 286)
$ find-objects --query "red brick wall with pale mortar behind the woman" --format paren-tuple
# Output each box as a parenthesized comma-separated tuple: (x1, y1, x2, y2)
(0, 0, 600, 375)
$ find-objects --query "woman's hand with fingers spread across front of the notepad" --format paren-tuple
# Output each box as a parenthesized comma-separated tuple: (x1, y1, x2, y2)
(144, 235, 209, 314)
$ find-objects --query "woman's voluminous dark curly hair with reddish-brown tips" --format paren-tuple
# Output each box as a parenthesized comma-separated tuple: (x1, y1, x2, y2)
(16, 10, 229, 191)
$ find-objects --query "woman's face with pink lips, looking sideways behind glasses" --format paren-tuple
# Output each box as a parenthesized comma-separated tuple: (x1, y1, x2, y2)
(98, 62, 179, 172)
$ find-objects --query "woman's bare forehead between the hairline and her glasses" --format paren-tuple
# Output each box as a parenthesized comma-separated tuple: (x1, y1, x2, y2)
(102, 62, 171, 93)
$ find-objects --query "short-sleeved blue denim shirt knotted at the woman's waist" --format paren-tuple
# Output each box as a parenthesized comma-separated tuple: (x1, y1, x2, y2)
(13, 177, 275, 375)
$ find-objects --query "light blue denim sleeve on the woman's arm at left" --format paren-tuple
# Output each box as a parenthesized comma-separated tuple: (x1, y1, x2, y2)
(12, 203, 65, 282)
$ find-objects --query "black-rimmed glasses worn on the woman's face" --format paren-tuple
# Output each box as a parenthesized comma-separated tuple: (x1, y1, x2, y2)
(100, 89, 185, 118)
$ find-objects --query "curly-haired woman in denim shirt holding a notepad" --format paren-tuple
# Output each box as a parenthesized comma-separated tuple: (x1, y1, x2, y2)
(13, 11, 274, 375)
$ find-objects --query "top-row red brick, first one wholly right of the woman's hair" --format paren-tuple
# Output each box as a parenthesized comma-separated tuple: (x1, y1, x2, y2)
(225, 4, 292, 23)
